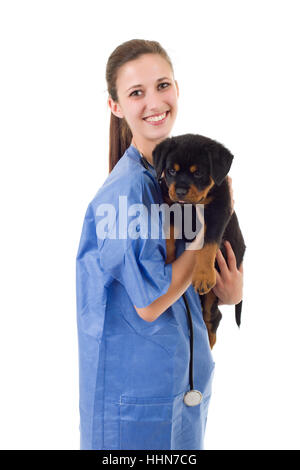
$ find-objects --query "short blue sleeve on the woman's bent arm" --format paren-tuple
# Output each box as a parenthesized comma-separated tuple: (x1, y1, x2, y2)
(98, 174, 172, 308)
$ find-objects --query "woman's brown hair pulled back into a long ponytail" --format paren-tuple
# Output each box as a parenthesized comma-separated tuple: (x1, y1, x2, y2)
(106, 39, 174, 172)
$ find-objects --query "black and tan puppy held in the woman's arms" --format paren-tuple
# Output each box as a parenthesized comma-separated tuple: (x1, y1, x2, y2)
(152, 134, 246, 348)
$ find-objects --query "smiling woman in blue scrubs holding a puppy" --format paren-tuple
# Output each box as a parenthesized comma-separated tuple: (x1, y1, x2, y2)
(77, 40, 242, 450)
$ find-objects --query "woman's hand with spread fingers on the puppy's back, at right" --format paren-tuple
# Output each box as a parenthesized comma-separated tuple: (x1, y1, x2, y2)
(212, 241, 243, 305)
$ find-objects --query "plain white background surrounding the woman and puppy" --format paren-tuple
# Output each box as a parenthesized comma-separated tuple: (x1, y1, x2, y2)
(0, 0, 300, 449)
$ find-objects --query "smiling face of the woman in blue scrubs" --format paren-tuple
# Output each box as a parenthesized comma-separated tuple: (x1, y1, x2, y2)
(109, 54, 179, 146)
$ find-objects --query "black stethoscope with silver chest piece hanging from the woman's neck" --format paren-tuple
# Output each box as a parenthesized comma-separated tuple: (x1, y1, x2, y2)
(138, 150, 203, 406)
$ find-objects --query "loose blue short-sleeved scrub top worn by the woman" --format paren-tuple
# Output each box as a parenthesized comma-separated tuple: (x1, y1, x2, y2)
(76, 145, 214, 450)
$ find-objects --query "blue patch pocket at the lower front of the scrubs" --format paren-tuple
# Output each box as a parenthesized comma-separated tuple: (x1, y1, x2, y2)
(120, 394, 183, 450)
